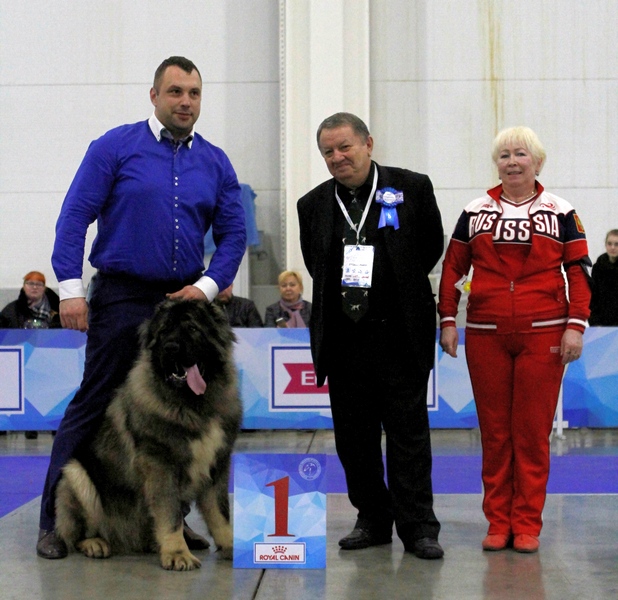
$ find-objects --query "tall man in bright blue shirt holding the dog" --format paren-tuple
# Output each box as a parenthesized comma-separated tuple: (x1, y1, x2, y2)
(37, 56, 246, 558)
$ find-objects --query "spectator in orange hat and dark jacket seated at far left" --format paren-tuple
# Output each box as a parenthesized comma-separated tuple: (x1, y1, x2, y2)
(0, 271, 61, 440)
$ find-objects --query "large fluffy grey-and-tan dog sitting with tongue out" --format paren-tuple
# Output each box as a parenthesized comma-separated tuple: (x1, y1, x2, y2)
(56, 300, 242, 571)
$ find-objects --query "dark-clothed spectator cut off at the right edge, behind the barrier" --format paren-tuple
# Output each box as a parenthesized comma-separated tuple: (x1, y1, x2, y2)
(589, 229, 618, 327)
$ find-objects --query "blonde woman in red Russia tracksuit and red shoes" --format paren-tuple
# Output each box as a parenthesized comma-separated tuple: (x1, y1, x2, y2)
(438, 127, 591, 552)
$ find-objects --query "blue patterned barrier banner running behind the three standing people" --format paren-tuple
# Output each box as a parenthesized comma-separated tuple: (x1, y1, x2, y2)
(0, 327, 618, 430)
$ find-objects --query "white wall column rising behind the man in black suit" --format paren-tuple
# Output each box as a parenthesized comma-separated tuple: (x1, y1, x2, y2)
(280, 0, 370, 298)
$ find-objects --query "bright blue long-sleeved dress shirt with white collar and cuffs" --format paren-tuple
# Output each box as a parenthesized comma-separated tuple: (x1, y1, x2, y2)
(52, 116, 246, 299)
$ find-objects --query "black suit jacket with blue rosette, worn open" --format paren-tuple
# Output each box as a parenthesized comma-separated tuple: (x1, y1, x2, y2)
(297, 165, 444, 386)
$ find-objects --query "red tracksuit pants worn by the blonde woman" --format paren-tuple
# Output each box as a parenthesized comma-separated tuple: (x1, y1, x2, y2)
(465, 329, 564, 536)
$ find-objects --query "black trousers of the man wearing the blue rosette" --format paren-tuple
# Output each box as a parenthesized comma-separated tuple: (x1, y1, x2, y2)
(328, 320, 440, 543)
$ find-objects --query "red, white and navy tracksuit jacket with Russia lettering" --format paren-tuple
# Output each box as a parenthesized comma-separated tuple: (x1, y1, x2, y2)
(438, 183, 591, 332)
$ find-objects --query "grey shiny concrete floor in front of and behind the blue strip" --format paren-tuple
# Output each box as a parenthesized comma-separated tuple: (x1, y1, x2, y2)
(0, 430, 618, 600)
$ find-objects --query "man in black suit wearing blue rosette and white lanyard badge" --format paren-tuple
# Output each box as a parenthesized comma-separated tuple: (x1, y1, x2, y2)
(298, 113, 444, 559)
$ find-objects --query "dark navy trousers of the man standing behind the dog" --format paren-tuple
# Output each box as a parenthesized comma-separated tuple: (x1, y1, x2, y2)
(40, 273, 194, 529)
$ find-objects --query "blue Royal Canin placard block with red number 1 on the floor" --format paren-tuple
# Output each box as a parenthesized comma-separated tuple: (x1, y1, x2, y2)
(234, 454, 326, 569)
